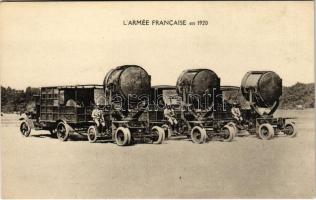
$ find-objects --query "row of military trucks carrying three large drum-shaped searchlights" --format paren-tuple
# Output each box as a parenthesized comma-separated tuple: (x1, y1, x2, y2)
(20, 65, 297, 146)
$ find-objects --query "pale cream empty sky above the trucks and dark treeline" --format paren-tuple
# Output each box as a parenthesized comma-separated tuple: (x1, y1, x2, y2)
(0, 1, 314, 89)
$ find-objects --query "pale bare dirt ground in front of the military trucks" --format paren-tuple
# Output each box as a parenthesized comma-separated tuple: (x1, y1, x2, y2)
(0, 110, 315, 199)
